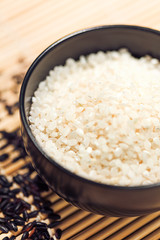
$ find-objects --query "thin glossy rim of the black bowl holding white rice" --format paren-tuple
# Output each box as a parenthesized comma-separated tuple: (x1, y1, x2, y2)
(19, 24, 160, 191)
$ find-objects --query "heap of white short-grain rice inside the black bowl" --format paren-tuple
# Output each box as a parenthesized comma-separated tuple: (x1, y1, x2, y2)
(29, 49, 160, 186)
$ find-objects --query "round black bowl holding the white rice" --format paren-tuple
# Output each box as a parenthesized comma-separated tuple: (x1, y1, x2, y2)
(20, 25, 160, 216)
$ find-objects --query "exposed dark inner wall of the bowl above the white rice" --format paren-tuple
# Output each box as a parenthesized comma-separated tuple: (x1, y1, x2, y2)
(23, 26, 160, 121)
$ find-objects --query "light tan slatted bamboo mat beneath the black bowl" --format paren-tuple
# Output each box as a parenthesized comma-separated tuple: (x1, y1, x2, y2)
(0, 0, 160, 240)
